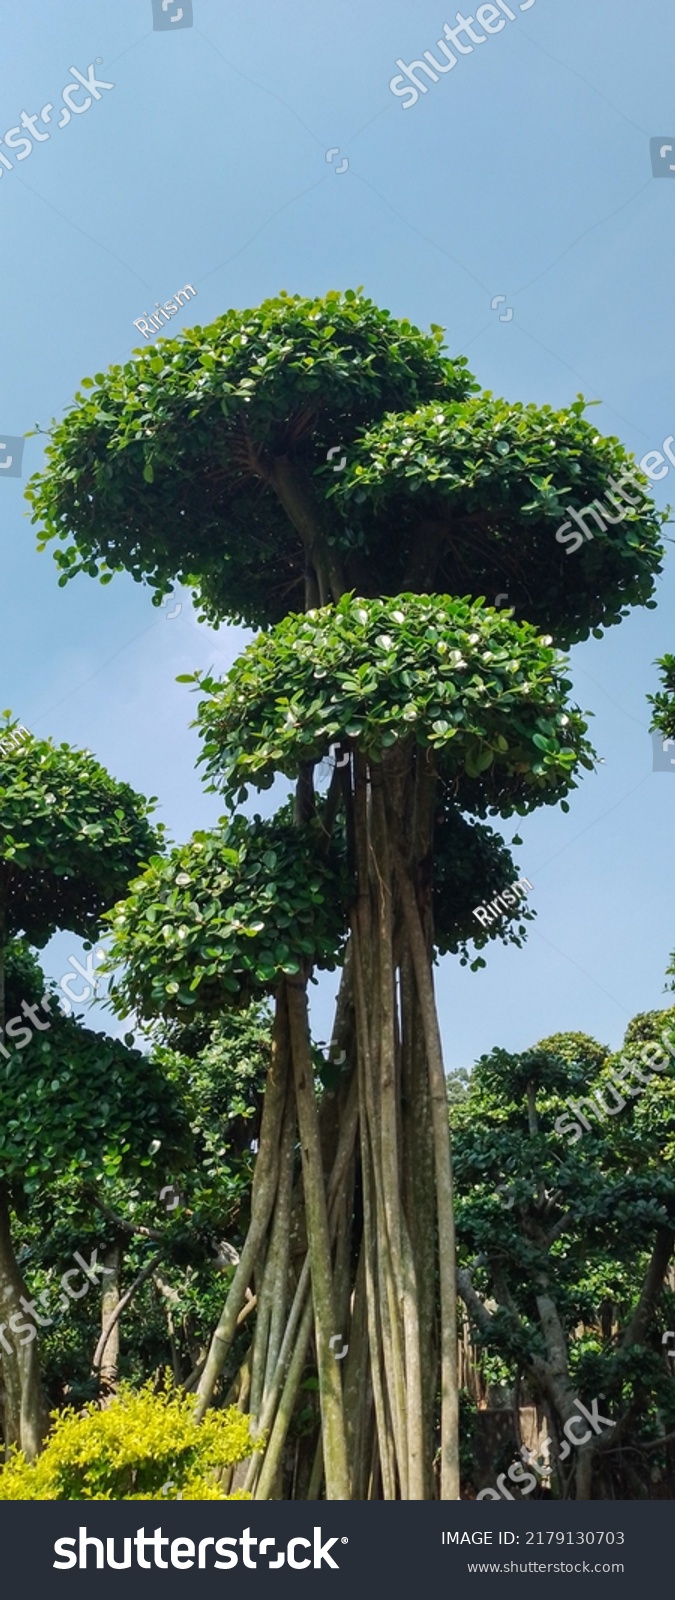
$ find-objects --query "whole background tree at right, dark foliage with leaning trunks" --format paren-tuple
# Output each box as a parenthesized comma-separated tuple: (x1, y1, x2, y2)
(451, 1011, 675, 1499)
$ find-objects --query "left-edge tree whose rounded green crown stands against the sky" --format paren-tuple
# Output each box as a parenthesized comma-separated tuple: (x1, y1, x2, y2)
(0, 720, 158, 1456)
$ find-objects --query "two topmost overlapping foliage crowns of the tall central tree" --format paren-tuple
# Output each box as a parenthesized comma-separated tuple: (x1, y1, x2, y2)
(27, 290, 664, 643)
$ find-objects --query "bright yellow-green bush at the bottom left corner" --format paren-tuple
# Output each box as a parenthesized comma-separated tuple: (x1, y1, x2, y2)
(0, 1384, 261, 1501)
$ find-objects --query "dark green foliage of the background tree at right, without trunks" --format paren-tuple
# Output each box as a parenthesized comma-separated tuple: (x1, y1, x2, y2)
(451, 1011, 675, 1443)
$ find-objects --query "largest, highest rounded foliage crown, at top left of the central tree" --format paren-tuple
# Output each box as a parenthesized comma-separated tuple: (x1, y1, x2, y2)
(27, 290, 475, 626)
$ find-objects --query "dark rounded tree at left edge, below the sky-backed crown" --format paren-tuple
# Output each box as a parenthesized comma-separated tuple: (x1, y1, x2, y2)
(0, 947, 187, 1458)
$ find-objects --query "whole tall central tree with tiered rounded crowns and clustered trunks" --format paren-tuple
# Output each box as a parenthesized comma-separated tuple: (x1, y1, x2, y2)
(30, 291, 661, 1499)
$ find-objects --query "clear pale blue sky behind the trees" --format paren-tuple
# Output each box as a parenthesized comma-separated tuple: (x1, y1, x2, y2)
(0, 0, 675, 1067)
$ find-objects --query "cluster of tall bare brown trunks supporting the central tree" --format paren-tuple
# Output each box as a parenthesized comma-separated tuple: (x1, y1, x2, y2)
(197, 736, 459, 1499)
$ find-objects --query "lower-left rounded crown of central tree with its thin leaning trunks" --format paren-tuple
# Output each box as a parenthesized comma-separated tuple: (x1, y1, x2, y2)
(110, 808, 347, 1497)
